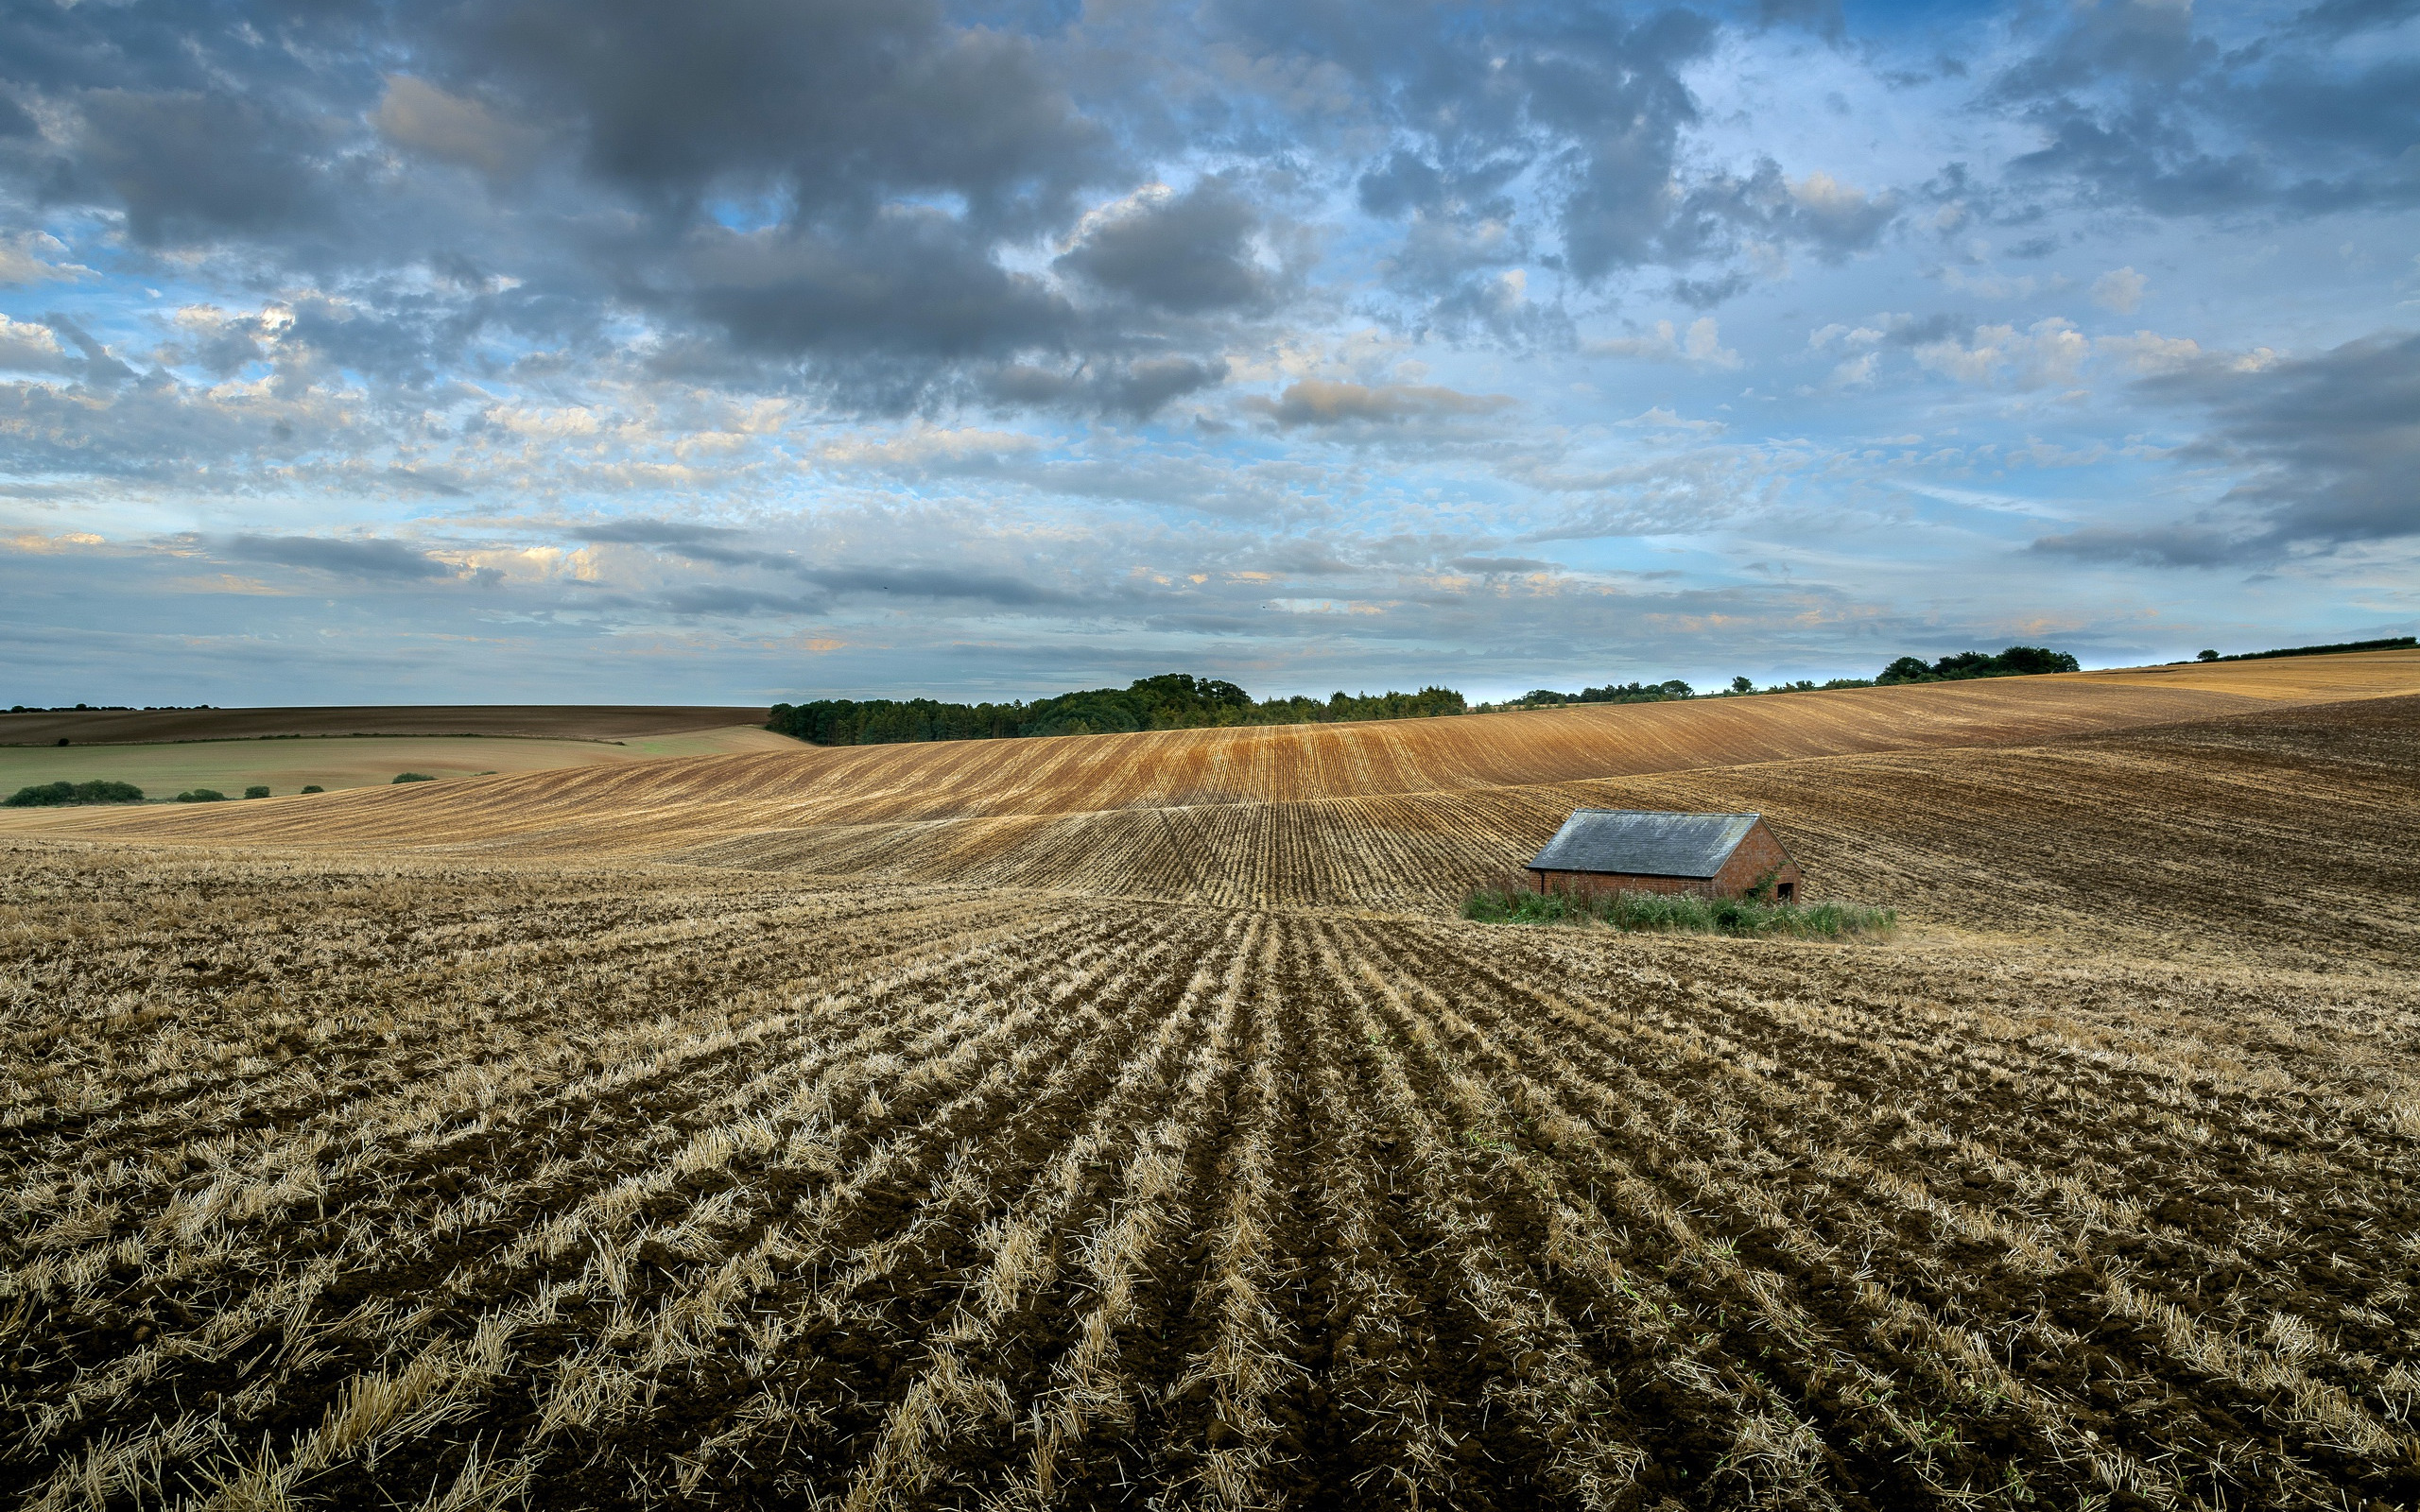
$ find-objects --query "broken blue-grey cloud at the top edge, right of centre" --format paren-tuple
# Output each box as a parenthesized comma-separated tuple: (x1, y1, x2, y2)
(1268, 0, 1894, 314)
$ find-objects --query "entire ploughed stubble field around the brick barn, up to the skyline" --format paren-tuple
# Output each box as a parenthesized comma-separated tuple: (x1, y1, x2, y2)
(0, 653, 2420, 1509)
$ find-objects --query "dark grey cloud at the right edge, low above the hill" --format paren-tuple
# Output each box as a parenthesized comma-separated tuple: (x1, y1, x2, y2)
(2032, 334, 2420, 566)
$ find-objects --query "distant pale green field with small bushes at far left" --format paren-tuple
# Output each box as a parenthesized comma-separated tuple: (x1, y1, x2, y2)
(0, 726, 801, 799)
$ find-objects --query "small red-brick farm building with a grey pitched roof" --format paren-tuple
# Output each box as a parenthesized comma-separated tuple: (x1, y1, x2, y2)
(1530, 808, 1798, 902)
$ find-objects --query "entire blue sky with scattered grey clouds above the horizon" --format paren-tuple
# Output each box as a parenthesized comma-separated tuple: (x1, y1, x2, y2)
(0, 0, 2420, 707)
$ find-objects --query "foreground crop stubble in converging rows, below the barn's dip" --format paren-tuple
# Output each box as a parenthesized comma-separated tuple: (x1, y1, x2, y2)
(0, 844, 2420, 1507)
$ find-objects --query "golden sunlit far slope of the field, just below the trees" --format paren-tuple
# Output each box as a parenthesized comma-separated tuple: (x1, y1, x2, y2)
(5, 651, 2420, 870)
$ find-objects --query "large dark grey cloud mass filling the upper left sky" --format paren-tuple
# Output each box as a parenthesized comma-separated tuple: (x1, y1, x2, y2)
(0, 0, 1137, 409)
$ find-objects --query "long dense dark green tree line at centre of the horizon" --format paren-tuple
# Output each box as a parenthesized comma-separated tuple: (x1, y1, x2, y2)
(765, 673, 1466, 745)
